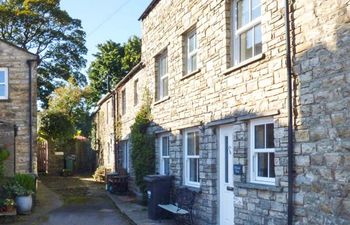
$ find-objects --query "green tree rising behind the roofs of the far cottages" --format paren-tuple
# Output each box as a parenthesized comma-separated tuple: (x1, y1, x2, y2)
(88, 36, 141, 104)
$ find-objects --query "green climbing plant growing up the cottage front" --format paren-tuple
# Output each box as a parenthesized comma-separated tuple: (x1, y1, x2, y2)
(130, 91, 155, 200)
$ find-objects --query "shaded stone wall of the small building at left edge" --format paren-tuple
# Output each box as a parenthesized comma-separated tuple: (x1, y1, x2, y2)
(0, 40, 37, 173)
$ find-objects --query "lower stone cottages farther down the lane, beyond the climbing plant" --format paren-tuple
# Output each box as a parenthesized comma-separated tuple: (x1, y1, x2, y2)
(93, 63, 147, 192)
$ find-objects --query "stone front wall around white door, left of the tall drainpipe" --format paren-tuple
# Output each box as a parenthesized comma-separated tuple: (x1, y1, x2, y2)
(142, 0, 287, 224)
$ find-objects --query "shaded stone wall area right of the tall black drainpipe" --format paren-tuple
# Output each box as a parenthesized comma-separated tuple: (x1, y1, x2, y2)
(294, 17, 350, 224)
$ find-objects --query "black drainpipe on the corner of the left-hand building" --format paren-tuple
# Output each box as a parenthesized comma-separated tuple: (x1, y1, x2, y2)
(27, 59, 38, 173)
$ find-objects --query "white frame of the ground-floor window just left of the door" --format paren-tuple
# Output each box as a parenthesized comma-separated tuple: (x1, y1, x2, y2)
(183, 129, 200, 188)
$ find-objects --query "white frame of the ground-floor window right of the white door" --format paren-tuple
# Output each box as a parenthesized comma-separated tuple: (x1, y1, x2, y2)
(249, 118, 276, 185)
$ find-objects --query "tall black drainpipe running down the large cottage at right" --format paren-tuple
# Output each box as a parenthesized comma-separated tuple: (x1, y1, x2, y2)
(285, 0, 294, 225)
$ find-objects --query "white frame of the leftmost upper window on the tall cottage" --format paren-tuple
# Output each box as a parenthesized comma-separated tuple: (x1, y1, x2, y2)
(156, 51, 169, 100)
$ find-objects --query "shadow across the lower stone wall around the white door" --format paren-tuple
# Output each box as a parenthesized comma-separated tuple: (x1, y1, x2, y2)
(152, 107, 288, 225)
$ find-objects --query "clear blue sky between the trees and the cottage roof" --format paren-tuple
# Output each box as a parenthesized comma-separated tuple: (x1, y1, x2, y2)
(61, 0, 151, 73)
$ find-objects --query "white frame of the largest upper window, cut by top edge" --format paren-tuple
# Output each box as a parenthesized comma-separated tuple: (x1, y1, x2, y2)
(231, 0, 263, 65)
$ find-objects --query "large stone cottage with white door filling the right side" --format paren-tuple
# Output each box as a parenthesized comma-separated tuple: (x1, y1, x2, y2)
(93, 0, 350, 225)
